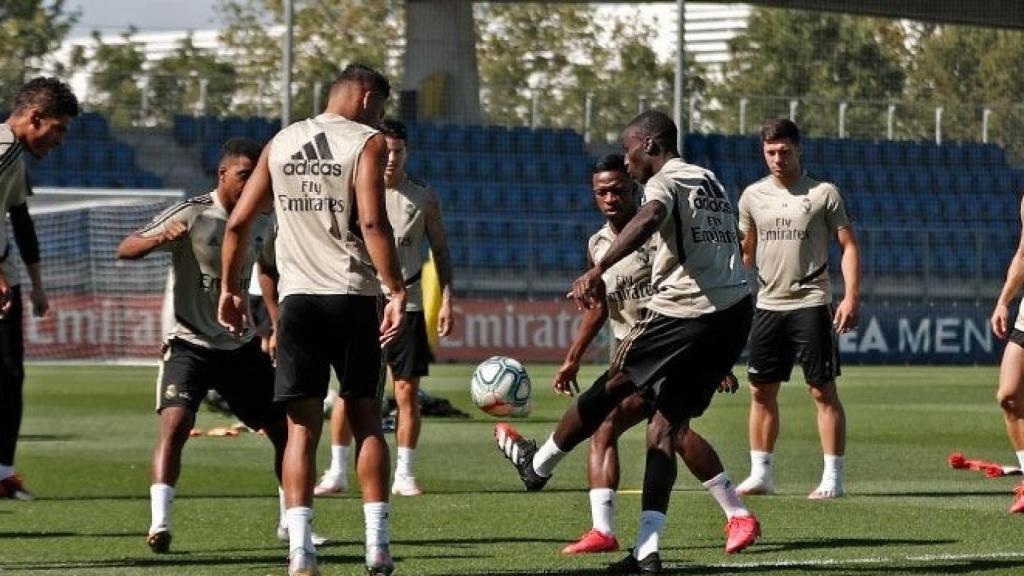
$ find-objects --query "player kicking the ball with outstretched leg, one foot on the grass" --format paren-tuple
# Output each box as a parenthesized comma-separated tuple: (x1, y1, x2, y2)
(495, 111, 753, 574)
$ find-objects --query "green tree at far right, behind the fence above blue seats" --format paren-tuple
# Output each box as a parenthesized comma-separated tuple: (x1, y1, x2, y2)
(905, 26, 1024, 152)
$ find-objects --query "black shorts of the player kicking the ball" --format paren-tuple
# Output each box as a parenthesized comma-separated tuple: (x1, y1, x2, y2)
(612, 296, 754, 424)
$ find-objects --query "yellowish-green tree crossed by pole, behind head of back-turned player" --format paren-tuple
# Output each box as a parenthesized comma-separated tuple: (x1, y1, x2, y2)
(218, 0, 404, 118)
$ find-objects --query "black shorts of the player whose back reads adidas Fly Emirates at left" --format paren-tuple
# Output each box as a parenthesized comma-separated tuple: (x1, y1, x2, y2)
(273, 294, 384, 402)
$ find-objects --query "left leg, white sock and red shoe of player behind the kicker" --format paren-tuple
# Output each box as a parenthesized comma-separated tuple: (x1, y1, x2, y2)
(562, 387, 650, 554)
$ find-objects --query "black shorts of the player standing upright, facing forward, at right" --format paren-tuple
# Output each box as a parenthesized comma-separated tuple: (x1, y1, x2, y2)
(746, 305, 840, 386)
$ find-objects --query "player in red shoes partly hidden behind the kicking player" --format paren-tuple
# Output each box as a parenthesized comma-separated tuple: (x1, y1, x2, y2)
(555, 154, 760, 554)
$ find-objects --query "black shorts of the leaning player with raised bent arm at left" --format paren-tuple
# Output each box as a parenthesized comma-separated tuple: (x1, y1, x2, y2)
(157, 338, 285, 429)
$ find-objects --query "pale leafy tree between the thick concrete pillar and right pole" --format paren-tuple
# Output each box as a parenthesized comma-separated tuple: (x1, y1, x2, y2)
(476, 3, 705, 139)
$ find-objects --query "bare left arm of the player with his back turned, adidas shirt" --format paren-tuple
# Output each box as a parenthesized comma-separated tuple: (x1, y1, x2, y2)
(217, 145, 273, 334)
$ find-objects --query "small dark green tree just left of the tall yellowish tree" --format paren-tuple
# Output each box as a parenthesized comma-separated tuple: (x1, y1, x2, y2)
(145, 34, 237, 124)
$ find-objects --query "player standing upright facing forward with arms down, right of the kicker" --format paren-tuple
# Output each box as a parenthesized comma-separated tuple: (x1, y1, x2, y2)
(737, 119, 860, 499)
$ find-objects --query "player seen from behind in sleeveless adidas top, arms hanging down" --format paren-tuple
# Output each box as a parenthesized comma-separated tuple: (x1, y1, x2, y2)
(219, 65, 407, 576)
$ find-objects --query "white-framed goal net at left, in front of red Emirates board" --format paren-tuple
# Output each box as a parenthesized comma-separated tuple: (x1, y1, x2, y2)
(20, 189, 184, 362)
